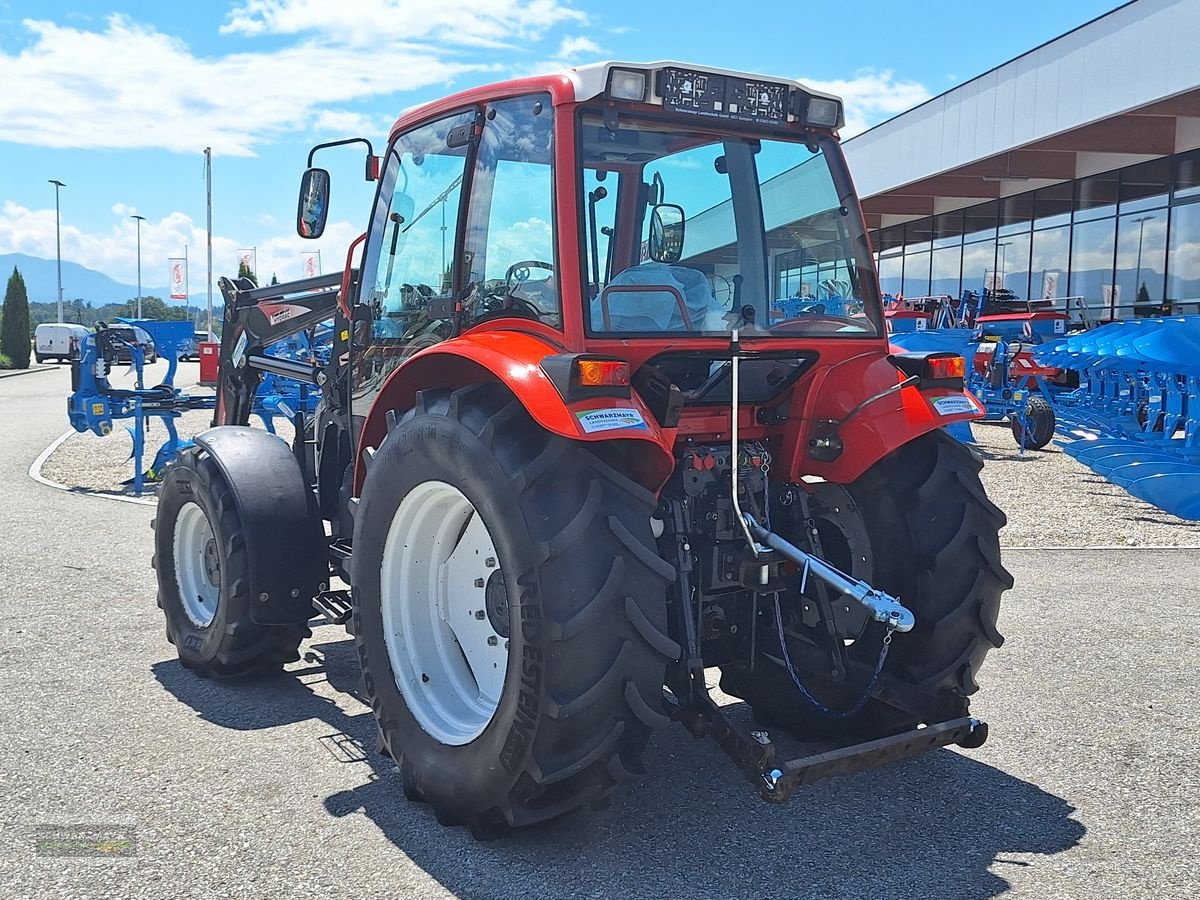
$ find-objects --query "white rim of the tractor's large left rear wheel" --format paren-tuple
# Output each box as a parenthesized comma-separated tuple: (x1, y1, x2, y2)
(379, 481, 509, 746)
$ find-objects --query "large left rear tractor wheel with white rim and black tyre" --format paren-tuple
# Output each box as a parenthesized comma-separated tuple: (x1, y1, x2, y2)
(353, 384, 678, 838)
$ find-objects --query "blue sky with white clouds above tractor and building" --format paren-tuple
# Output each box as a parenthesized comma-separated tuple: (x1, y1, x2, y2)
(0, 0, 1132, 299)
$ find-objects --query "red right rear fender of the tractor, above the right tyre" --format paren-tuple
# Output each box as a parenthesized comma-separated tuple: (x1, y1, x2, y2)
(785, 353, 984, 484)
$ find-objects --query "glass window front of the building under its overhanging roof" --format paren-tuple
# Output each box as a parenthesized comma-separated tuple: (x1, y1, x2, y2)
(871, 150, 1200, 320)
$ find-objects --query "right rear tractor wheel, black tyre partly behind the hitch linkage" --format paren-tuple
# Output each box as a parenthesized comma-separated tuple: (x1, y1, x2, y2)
(721, 431, 1013, 740)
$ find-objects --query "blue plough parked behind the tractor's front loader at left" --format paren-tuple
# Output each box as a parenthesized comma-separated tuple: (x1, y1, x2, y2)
(67, 309, 331, 494)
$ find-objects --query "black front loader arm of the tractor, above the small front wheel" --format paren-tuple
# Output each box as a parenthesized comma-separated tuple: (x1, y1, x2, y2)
(212, 272, 346, 425)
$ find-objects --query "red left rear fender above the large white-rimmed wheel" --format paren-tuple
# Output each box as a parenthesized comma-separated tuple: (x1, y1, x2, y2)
(354, 331, 676, 493)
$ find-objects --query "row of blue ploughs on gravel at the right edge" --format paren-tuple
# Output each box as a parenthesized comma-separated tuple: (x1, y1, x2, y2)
(1034, 316, 1200, 521)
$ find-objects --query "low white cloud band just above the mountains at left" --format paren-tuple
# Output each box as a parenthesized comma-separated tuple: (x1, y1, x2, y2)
(0, 200, 361, 299)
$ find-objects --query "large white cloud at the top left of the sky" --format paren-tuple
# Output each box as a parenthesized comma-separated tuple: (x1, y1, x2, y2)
(0, 0, 587, 156)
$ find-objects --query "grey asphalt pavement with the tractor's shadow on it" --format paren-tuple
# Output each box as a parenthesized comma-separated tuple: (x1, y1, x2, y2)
(0, 364, 1200, 900)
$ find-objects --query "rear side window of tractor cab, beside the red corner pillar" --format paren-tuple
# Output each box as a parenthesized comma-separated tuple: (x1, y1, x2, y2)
(463, 94, 562, 328)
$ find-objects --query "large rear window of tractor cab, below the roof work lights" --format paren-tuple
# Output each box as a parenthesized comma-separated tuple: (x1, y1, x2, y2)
(580, 112, 881, 338)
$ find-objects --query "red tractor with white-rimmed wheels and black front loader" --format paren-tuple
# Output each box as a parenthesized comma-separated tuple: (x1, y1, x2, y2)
(155, 62, 1012, 836)
